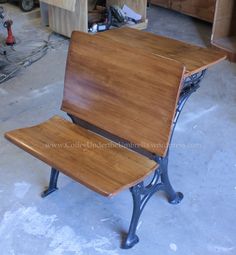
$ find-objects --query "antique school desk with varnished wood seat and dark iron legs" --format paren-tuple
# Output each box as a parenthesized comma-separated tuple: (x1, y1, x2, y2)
(5, 29, 224, 249)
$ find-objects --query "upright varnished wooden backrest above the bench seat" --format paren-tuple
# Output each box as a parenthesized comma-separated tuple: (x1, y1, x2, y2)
(62, 32, 184, 156)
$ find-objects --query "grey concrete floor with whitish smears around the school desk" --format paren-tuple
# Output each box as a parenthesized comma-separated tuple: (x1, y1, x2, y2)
(0, 5, 236, 255)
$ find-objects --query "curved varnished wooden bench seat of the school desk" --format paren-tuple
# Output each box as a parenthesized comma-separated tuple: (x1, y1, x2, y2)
(5, 116, 158, 196)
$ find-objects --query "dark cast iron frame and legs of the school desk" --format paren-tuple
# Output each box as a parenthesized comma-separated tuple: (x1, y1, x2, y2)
(42, 70, 206, 249)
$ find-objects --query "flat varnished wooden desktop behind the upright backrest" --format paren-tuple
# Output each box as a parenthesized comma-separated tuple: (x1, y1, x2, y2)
(99, 28, 226, 77)
